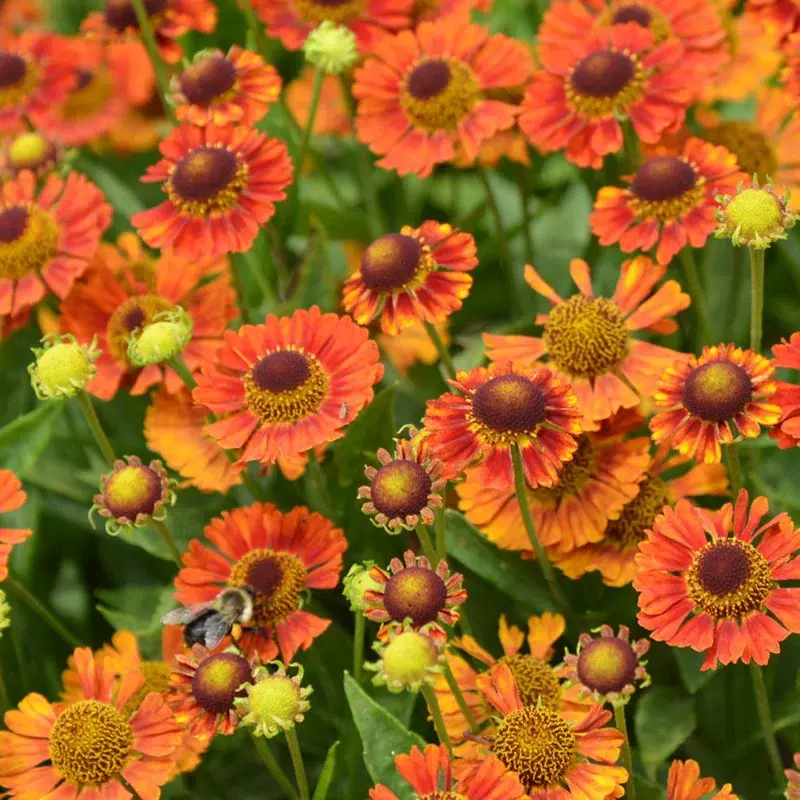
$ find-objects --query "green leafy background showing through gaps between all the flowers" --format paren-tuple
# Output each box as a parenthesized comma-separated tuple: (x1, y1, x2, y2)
(0, 0, 800, 800)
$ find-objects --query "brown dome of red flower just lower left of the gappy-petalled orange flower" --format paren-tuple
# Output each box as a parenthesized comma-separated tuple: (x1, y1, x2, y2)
(472, 375, 547, 433)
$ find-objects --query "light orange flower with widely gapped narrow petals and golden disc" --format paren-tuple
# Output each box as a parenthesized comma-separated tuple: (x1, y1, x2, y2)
(483, 256, 690, 430)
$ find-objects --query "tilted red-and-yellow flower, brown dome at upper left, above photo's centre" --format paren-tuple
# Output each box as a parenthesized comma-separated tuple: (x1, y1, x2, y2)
(342, 220, 478, 334)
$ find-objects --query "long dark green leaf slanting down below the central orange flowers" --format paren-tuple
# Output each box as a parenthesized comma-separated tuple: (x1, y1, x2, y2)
(445, 509, 555, 613)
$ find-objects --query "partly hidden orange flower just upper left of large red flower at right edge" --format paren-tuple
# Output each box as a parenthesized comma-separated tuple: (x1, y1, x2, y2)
(550, 447, 728, 586)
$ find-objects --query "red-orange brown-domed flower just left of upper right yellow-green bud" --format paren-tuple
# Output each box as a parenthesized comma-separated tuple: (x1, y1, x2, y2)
(589, 138, 746, 264)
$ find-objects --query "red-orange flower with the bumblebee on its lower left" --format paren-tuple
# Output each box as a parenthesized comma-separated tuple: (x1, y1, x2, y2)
(175, 503, 347, 664)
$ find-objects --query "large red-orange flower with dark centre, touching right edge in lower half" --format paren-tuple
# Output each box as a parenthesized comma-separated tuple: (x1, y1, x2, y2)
(633, 489, 800, 670)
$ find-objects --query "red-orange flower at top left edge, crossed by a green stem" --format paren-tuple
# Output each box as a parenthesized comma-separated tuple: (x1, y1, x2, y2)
(83, 0, 217, 64)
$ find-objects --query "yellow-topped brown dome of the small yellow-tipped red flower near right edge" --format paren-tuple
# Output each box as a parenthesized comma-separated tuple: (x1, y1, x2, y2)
(683, 361, 753, 422)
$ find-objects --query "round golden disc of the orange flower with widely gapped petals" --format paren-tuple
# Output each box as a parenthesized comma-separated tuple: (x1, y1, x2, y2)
(544, 294, 629, 378)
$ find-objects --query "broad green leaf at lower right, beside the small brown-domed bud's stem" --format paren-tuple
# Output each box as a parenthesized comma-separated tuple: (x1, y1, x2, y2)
(634, 686, 697, 777)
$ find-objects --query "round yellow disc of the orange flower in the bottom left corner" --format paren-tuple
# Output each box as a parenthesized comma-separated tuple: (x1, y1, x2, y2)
(49, 700, 133, 788)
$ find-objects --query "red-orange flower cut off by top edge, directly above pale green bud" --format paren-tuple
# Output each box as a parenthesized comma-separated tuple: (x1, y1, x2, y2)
(253, 0, 412, 52)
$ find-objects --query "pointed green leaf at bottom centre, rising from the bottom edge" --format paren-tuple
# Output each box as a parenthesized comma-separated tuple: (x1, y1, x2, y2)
(344, 672, 425, 800)
